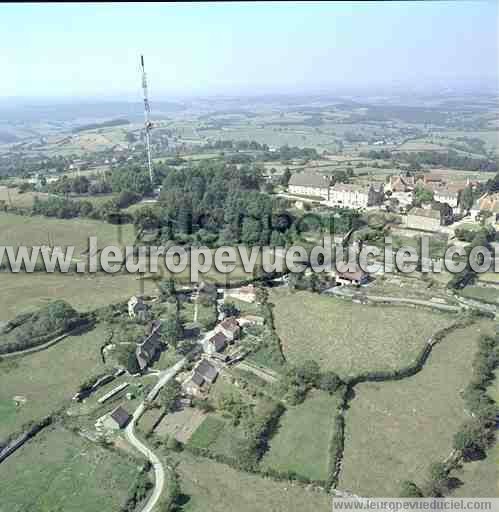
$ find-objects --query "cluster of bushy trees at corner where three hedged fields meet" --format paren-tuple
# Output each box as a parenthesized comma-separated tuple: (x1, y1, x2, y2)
(279, 359, 344, 405)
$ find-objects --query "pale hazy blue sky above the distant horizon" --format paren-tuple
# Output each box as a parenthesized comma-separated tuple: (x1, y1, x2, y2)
(0, 0, 499, 100)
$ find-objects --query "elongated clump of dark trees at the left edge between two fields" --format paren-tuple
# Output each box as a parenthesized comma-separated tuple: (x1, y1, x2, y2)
(0, 300, 86, 353)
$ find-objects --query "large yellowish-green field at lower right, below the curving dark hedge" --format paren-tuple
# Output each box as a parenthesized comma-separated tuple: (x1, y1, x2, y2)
(338, 320, 493, 496)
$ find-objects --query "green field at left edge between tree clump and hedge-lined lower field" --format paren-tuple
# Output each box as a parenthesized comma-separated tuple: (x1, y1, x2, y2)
(0, 325, 110, 439)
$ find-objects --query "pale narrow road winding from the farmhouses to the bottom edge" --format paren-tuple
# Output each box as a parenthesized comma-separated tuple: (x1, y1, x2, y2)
(125, 357, 187, 512)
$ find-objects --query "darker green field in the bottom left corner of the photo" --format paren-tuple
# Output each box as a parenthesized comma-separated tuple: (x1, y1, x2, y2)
(0, 427, 137, 512)
